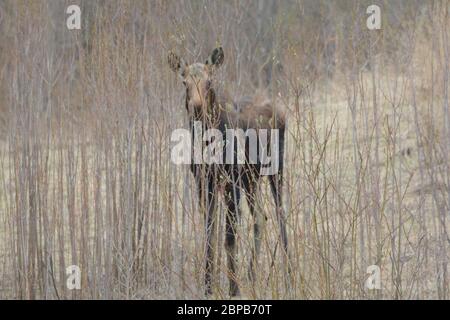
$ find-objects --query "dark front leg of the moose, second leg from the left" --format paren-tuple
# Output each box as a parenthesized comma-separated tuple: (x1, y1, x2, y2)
(225, 183, 240, 297)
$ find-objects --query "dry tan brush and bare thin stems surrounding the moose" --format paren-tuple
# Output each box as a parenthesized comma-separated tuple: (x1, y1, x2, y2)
(0, 0, 450, 299)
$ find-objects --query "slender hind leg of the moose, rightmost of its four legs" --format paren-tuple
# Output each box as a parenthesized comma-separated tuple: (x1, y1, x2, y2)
(270, 174, 291, 287)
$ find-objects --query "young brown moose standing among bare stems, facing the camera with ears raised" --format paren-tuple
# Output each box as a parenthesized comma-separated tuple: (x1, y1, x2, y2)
(168, 47, 290, 297)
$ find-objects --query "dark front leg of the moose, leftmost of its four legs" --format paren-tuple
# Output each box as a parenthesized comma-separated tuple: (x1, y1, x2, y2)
(197, 170, 217, 295)
